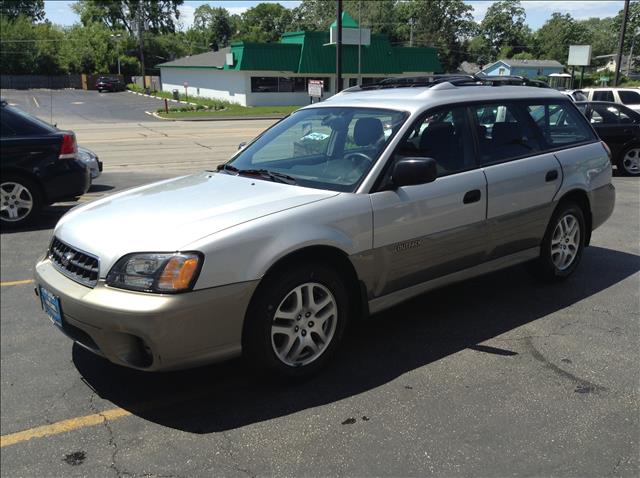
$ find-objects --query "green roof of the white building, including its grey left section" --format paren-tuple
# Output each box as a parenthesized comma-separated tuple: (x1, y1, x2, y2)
(158, 32, 442, 76)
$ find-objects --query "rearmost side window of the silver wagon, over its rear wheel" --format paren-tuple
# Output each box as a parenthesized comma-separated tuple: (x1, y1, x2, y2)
(527, 102, 594, 149)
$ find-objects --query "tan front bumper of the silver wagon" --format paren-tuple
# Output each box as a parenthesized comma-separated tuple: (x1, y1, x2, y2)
(35, 259, 258, 371)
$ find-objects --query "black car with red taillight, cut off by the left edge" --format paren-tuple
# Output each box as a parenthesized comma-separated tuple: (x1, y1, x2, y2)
(0, 101, 91, 227)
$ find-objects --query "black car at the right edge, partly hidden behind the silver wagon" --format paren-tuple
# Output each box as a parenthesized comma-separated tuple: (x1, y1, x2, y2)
(576, 101, 640, 176)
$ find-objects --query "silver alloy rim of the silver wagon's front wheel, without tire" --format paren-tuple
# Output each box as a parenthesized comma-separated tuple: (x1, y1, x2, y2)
(271, 282, 338, 367)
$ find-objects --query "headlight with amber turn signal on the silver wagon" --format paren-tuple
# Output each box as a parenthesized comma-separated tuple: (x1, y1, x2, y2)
(107, 252, 202, 293)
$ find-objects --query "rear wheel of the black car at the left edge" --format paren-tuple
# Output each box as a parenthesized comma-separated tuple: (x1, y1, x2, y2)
(0, 174, 43, 227)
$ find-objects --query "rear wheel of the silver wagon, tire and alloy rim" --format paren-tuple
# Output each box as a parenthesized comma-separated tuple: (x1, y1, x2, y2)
(530, 201, 587, 281)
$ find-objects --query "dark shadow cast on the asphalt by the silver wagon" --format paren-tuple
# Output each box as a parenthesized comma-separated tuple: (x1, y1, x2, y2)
(73, 247, 640, 433)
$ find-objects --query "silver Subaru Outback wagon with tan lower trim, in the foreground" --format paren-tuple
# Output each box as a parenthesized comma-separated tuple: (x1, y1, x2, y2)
(35, 81, 615, 376)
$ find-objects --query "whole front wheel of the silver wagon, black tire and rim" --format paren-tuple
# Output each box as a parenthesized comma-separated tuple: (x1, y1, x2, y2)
(243, 264, 349, 378)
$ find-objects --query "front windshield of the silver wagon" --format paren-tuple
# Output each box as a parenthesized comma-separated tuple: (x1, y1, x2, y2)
(223, 107, 408, 192)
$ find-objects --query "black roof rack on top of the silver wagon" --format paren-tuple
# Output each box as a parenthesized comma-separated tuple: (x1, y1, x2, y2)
(343, 74, 549, 92)
